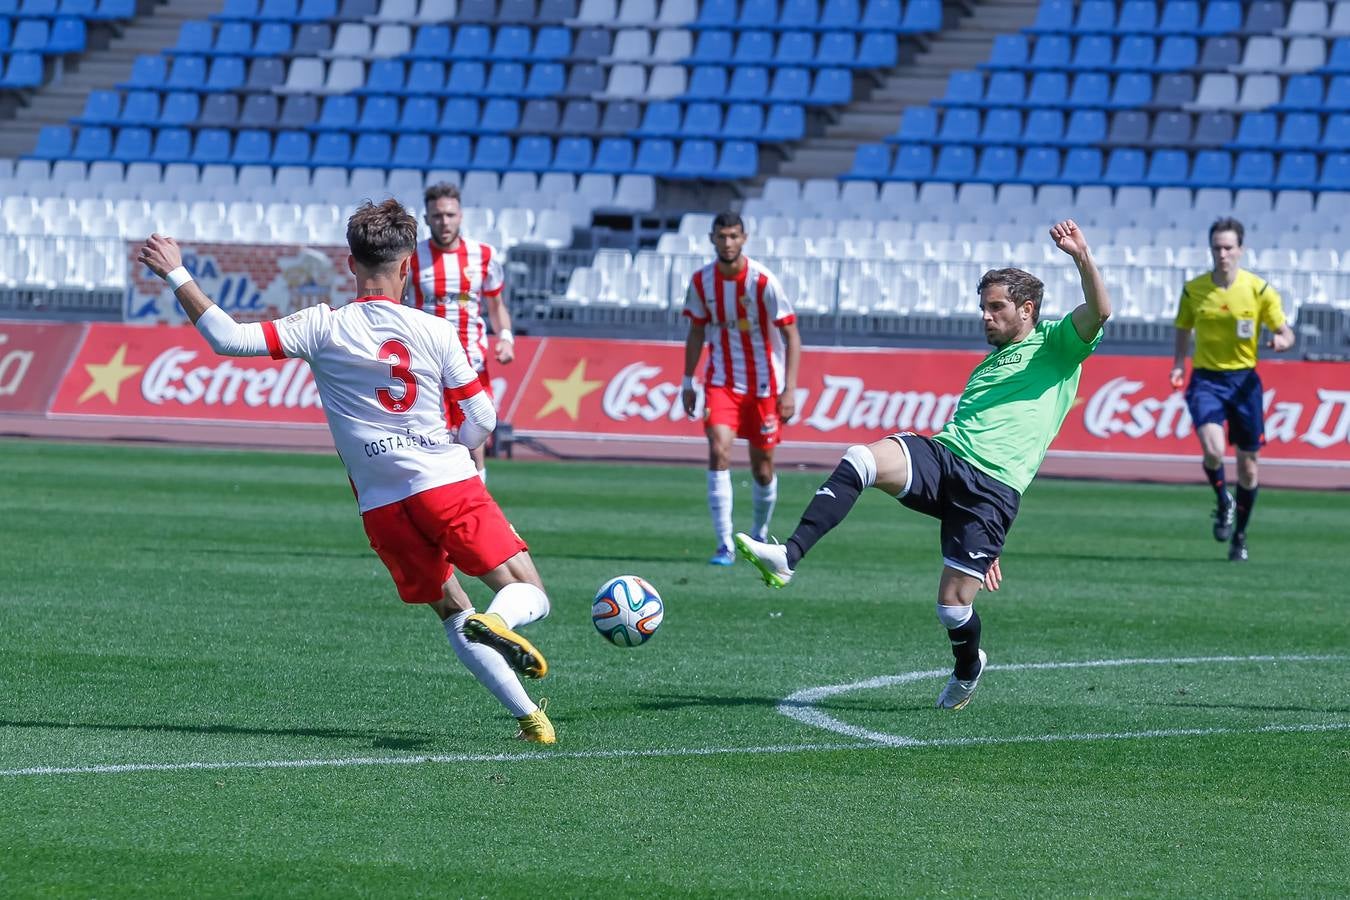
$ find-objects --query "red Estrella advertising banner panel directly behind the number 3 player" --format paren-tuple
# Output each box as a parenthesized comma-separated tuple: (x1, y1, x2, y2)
(51, 325, 537, 425)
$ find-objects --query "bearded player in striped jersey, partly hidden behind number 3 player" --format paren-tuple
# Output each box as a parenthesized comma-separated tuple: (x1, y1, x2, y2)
(410, 182, 516, 476)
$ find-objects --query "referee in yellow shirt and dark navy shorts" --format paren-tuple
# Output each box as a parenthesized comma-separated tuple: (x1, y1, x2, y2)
(1172, 219, 1293, 561)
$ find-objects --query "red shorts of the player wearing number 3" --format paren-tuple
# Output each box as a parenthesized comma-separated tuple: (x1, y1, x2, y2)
(360, 478, 529, 603)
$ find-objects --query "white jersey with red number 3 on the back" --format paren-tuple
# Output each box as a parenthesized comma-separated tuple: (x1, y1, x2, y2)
(262, 297, 482, 513)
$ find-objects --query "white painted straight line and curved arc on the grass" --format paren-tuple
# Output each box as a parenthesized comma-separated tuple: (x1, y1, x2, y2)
(0, 656, 1350, 779)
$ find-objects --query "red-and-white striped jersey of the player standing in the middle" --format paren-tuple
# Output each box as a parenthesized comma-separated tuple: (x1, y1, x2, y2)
(684, 256, 797, 397)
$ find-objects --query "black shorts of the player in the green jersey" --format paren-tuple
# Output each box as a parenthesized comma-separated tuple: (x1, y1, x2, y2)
(894, 433, 1022, 578)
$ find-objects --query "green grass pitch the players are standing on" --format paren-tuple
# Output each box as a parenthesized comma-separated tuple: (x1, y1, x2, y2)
(0, 441, 1350, 897)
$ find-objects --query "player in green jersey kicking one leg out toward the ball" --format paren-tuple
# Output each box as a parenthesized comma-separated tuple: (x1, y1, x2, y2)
(736, 220, 1111, 710)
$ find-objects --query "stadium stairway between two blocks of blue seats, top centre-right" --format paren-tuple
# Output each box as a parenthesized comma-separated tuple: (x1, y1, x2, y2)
(747, 0, 1040, 183)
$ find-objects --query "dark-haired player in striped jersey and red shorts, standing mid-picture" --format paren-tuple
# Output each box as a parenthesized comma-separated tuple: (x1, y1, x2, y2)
(680, 212, 802, 565)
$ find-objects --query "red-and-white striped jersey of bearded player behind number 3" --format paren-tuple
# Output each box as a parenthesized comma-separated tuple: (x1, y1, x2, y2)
(412, 236, 505, 372)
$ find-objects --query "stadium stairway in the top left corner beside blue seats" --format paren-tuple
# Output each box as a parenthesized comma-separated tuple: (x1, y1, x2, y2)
(0, 0, 224, 159)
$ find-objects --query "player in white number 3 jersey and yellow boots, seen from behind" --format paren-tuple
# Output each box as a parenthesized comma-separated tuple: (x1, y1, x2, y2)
(138, 200, 555, 743)
